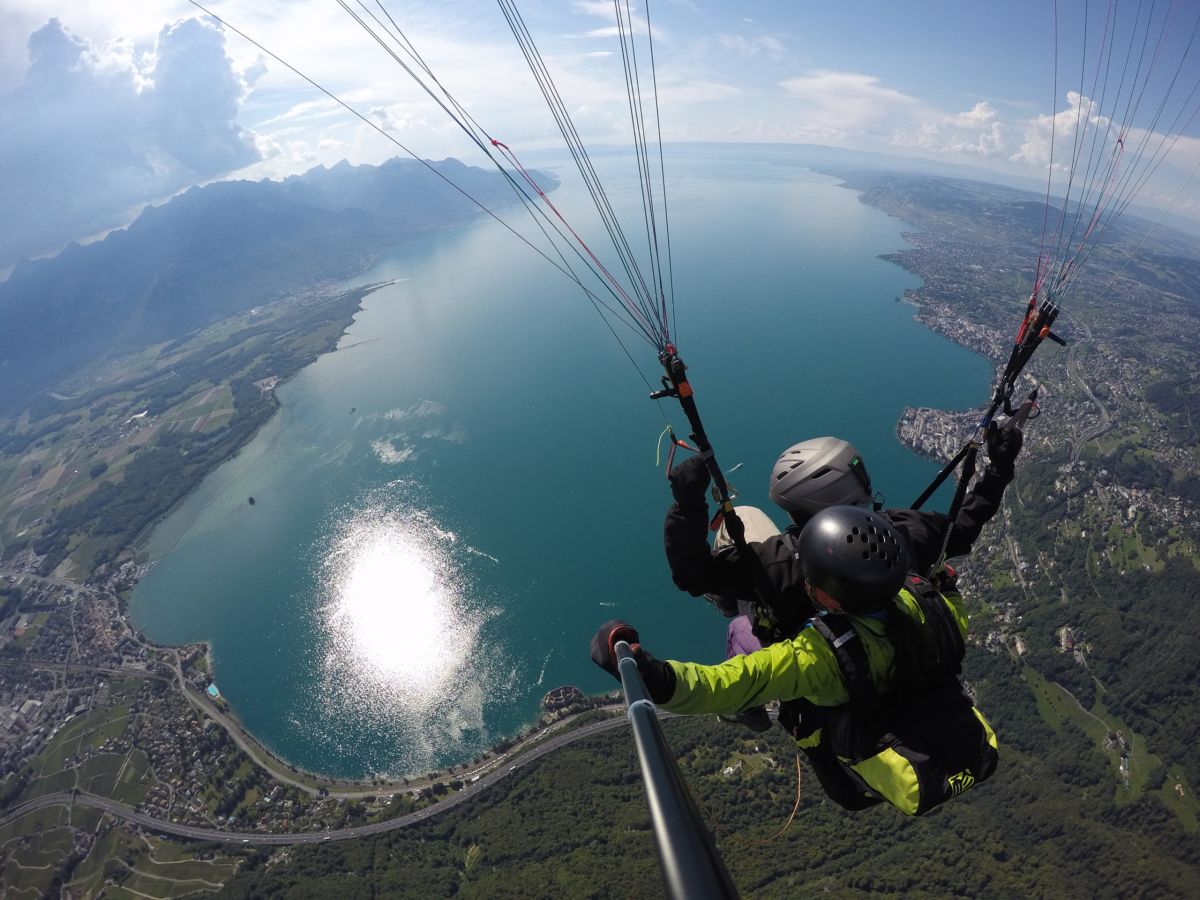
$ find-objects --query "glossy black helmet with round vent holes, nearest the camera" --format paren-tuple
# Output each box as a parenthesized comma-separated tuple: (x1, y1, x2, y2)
(798, 506, 908, 613)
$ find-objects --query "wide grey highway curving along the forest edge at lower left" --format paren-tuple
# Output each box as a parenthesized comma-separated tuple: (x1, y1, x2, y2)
(0, 713, 638, 846)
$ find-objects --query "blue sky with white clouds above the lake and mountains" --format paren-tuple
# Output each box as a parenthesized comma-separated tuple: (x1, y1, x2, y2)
(0, 0, 1200, 265)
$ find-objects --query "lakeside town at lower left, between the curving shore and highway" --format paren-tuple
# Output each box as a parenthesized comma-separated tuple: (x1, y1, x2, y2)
(0, 563, 613, 833)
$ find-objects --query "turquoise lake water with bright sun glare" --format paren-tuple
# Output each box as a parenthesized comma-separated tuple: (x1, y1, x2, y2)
(132, 151, 989, 776)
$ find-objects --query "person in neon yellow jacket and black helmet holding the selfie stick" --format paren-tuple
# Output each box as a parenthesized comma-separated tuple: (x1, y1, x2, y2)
(590, 505, 998, 815)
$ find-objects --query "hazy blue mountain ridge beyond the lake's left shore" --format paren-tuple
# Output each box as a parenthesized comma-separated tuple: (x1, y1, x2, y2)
(0, 158, 557, 413)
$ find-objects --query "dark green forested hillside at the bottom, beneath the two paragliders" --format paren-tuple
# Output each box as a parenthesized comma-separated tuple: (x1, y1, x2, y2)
(222, 705, 1200, 898)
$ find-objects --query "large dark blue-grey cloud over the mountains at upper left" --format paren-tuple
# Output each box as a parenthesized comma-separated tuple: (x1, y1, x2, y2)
(0, 19, 263, 265)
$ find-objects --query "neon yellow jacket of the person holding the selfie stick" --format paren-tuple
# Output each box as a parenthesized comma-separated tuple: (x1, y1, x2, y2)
(659, 588, 967, 714)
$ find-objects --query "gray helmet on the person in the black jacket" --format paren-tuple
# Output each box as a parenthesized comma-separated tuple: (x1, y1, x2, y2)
(770, 438, 872, 514)
